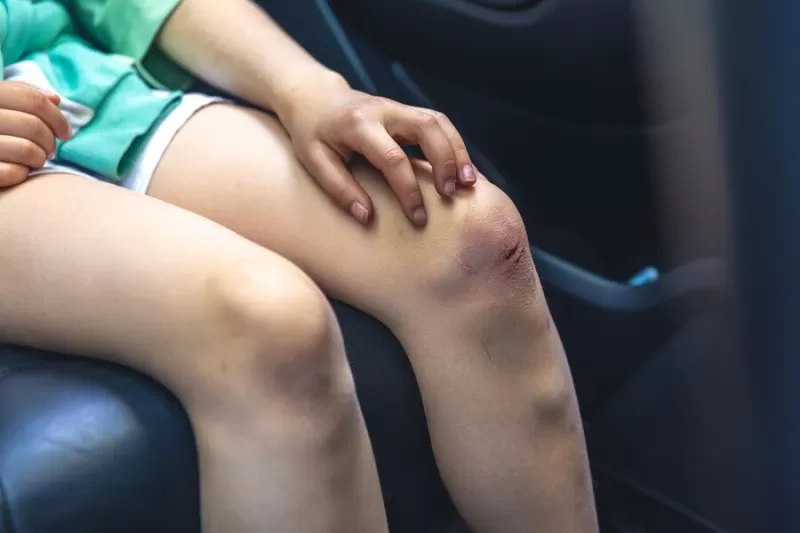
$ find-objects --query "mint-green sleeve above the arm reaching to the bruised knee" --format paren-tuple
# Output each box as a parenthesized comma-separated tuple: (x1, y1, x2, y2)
(62, 0, 192, 89)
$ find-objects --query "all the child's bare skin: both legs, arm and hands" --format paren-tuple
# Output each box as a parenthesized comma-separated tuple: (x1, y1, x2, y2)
(0, 0, 597, 533)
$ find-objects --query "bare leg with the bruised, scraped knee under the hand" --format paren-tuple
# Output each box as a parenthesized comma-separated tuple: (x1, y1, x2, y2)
(150, 105, 597, 533)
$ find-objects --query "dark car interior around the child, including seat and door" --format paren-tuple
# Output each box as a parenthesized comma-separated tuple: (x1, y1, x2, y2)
(0, 0, 800, 533)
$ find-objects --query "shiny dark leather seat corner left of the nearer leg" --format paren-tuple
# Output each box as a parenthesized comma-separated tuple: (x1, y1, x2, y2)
(0, 347, 200, 533)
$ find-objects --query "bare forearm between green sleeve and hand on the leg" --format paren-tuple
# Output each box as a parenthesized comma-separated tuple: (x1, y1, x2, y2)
(158, 0, 346, 121)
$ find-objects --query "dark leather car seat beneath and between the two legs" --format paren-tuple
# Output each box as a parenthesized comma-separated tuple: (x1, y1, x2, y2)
(0, 304, 466, 533)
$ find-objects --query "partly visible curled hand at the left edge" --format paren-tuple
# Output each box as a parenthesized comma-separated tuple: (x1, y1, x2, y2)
(0, 81, 72, 188)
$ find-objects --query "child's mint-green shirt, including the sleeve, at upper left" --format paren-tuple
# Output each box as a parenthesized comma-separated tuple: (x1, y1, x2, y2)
(0, 0, 192, 181)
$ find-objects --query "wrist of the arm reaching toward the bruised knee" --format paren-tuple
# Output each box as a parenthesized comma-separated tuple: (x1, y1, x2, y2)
(272, 67, 350, 129)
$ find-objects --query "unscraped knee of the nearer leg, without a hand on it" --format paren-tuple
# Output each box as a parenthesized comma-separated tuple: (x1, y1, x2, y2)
(192, 264, 353, 409)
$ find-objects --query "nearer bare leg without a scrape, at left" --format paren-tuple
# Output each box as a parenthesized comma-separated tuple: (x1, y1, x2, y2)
(0, 175, 386, 533)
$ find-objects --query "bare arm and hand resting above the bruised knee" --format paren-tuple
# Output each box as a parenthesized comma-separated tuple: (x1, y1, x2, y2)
(159, 0, 476, 226)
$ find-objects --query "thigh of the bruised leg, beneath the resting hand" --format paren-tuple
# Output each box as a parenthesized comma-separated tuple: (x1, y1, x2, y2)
(148, 105, 507, 319)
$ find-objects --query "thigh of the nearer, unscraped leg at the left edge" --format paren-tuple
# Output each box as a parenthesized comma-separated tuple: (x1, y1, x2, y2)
(0, 174, 311, 386)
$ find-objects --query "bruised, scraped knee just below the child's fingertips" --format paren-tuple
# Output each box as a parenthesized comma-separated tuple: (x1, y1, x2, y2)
(392, 182, 558, 374)
